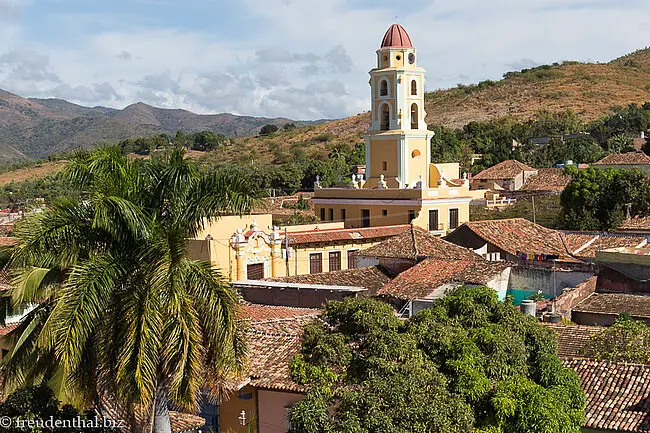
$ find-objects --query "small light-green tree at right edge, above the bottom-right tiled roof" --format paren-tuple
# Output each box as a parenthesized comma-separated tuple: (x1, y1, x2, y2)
(588, 313, 650, 364)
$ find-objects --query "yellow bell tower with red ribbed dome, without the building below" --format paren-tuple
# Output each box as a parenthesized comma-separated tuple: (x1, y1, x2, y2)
(365, 24, 435, 188)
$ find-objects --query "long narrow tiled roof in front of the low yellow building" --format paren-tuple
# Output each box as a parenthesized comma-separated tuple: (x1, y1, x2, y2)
(268, 266, 391, 296)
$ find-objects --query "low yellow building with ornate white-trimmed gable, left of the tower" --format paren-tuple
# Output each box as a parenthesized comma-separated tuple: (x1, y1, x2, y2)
(188, 214, 408, 281)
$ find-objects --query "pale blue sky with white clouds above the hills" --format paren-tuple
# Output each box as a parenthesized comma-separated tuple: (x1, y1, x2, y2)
(0, 0, 650, 120)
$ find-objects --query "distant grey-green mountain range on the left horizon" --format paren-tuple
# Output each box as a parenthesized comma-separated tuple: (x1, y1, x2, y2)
(0, 90, 313, 163)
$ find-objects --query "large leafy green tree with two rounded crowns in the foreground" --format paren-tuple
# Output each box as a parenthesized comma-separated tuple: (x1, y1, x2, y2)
(290, 287, 585, 433)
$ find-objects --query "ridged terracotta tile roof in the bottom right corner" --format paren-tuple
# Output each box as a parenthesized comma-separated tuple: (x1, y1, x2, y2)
(563, 359, 650, 433)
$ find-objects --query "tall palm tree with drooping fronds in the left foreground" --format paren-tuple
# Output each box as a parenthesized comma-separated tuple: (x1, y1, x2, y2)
(3, 147, 255, 432)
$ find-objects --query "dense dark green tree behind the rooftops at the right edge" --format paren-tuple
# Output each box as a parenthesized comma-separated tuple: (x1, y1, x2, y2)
(560, 167, 650, 230)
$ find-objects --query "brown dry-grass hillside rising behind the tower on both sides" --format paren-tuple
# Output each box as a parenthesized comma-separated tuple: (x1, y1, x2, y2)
(213, 49, 650, 161)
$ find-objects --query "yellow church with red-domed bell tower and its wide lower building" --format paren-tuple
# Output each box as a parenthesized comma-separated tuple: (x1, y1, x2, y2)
(313, 24, 485, 234)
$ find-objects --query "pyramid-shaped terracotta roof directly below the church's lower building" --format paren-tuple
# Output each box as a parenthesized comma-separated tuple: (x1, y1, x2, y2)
(357, 227, 482, 260)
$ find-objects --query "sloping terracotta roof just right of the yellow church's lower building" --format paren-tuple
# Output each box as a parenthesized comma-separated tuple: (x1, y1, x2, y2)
(454, 218, 578, 262)
